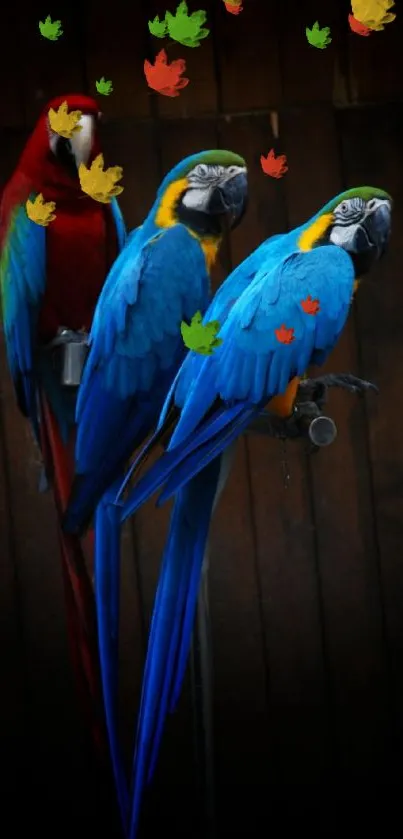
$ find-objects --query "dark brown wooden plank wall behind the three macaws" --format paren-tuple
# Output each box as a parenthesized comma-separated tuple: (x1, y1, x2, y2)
(0, 0, 403, 837)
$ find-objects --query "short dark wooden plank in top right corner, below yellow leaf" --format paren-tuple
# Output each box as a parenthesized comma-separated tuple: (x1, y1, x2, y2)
(348, 13, 403, 102)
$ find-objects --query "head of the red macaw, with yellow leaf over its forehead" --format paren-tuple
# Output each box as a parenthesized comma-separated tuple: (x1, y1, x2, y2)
(18, 93, 104, 200)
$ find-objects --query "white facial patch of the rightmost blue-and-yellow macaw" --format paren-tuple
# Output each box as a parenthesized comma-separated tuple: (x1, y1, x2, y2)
(329, 197, 390, 253)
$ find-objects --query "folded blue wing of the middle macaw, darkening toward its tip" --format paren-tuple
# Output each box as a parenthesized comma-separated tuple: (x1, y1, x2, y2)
(65, 225, 209, 528)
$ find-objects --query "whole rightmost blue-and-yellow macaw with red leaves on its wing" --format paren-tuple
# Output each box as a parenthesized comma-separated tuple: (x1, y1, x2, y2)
(115, 186, 392, 839)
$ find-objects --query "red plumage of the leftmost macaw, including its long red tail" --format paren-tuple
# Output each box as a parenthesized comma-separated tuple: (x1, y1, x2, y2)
(0, 94, 122, 772)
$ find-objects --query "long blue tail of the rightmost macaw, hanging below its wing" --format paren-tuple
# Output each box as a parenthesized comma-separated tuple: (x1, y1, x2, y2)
(129, 459, 220, 839)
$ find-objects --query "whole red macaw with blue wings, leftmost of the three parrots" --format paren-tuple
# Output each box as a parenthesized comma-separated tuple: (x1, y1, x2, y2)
(0, 94, 126, 761)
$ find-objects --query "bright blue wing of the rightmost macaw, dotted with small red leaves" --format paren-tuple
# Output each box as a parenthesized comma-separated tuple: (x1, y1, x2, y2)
(122, 246, 354, 518)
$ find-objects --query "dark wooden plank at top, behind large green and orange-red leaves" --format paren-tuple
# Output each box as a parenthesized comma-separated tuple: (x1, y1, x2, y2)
(148, 0, 217, 118)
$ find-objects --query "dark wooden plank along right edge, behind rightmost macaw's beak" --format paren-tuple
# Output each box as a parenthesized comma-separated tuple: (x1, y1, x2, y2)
(340, 105, 403, 783)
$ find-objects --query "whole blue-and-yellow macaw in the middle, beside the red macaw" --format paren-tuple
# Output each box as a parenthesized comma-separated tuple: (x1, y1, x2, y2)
(63, 149, 247, 825)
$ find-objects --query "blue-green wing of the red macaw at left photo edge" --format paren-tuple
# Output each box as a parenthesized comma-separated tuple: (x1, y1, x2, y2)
(0, 196, 46, 434)
